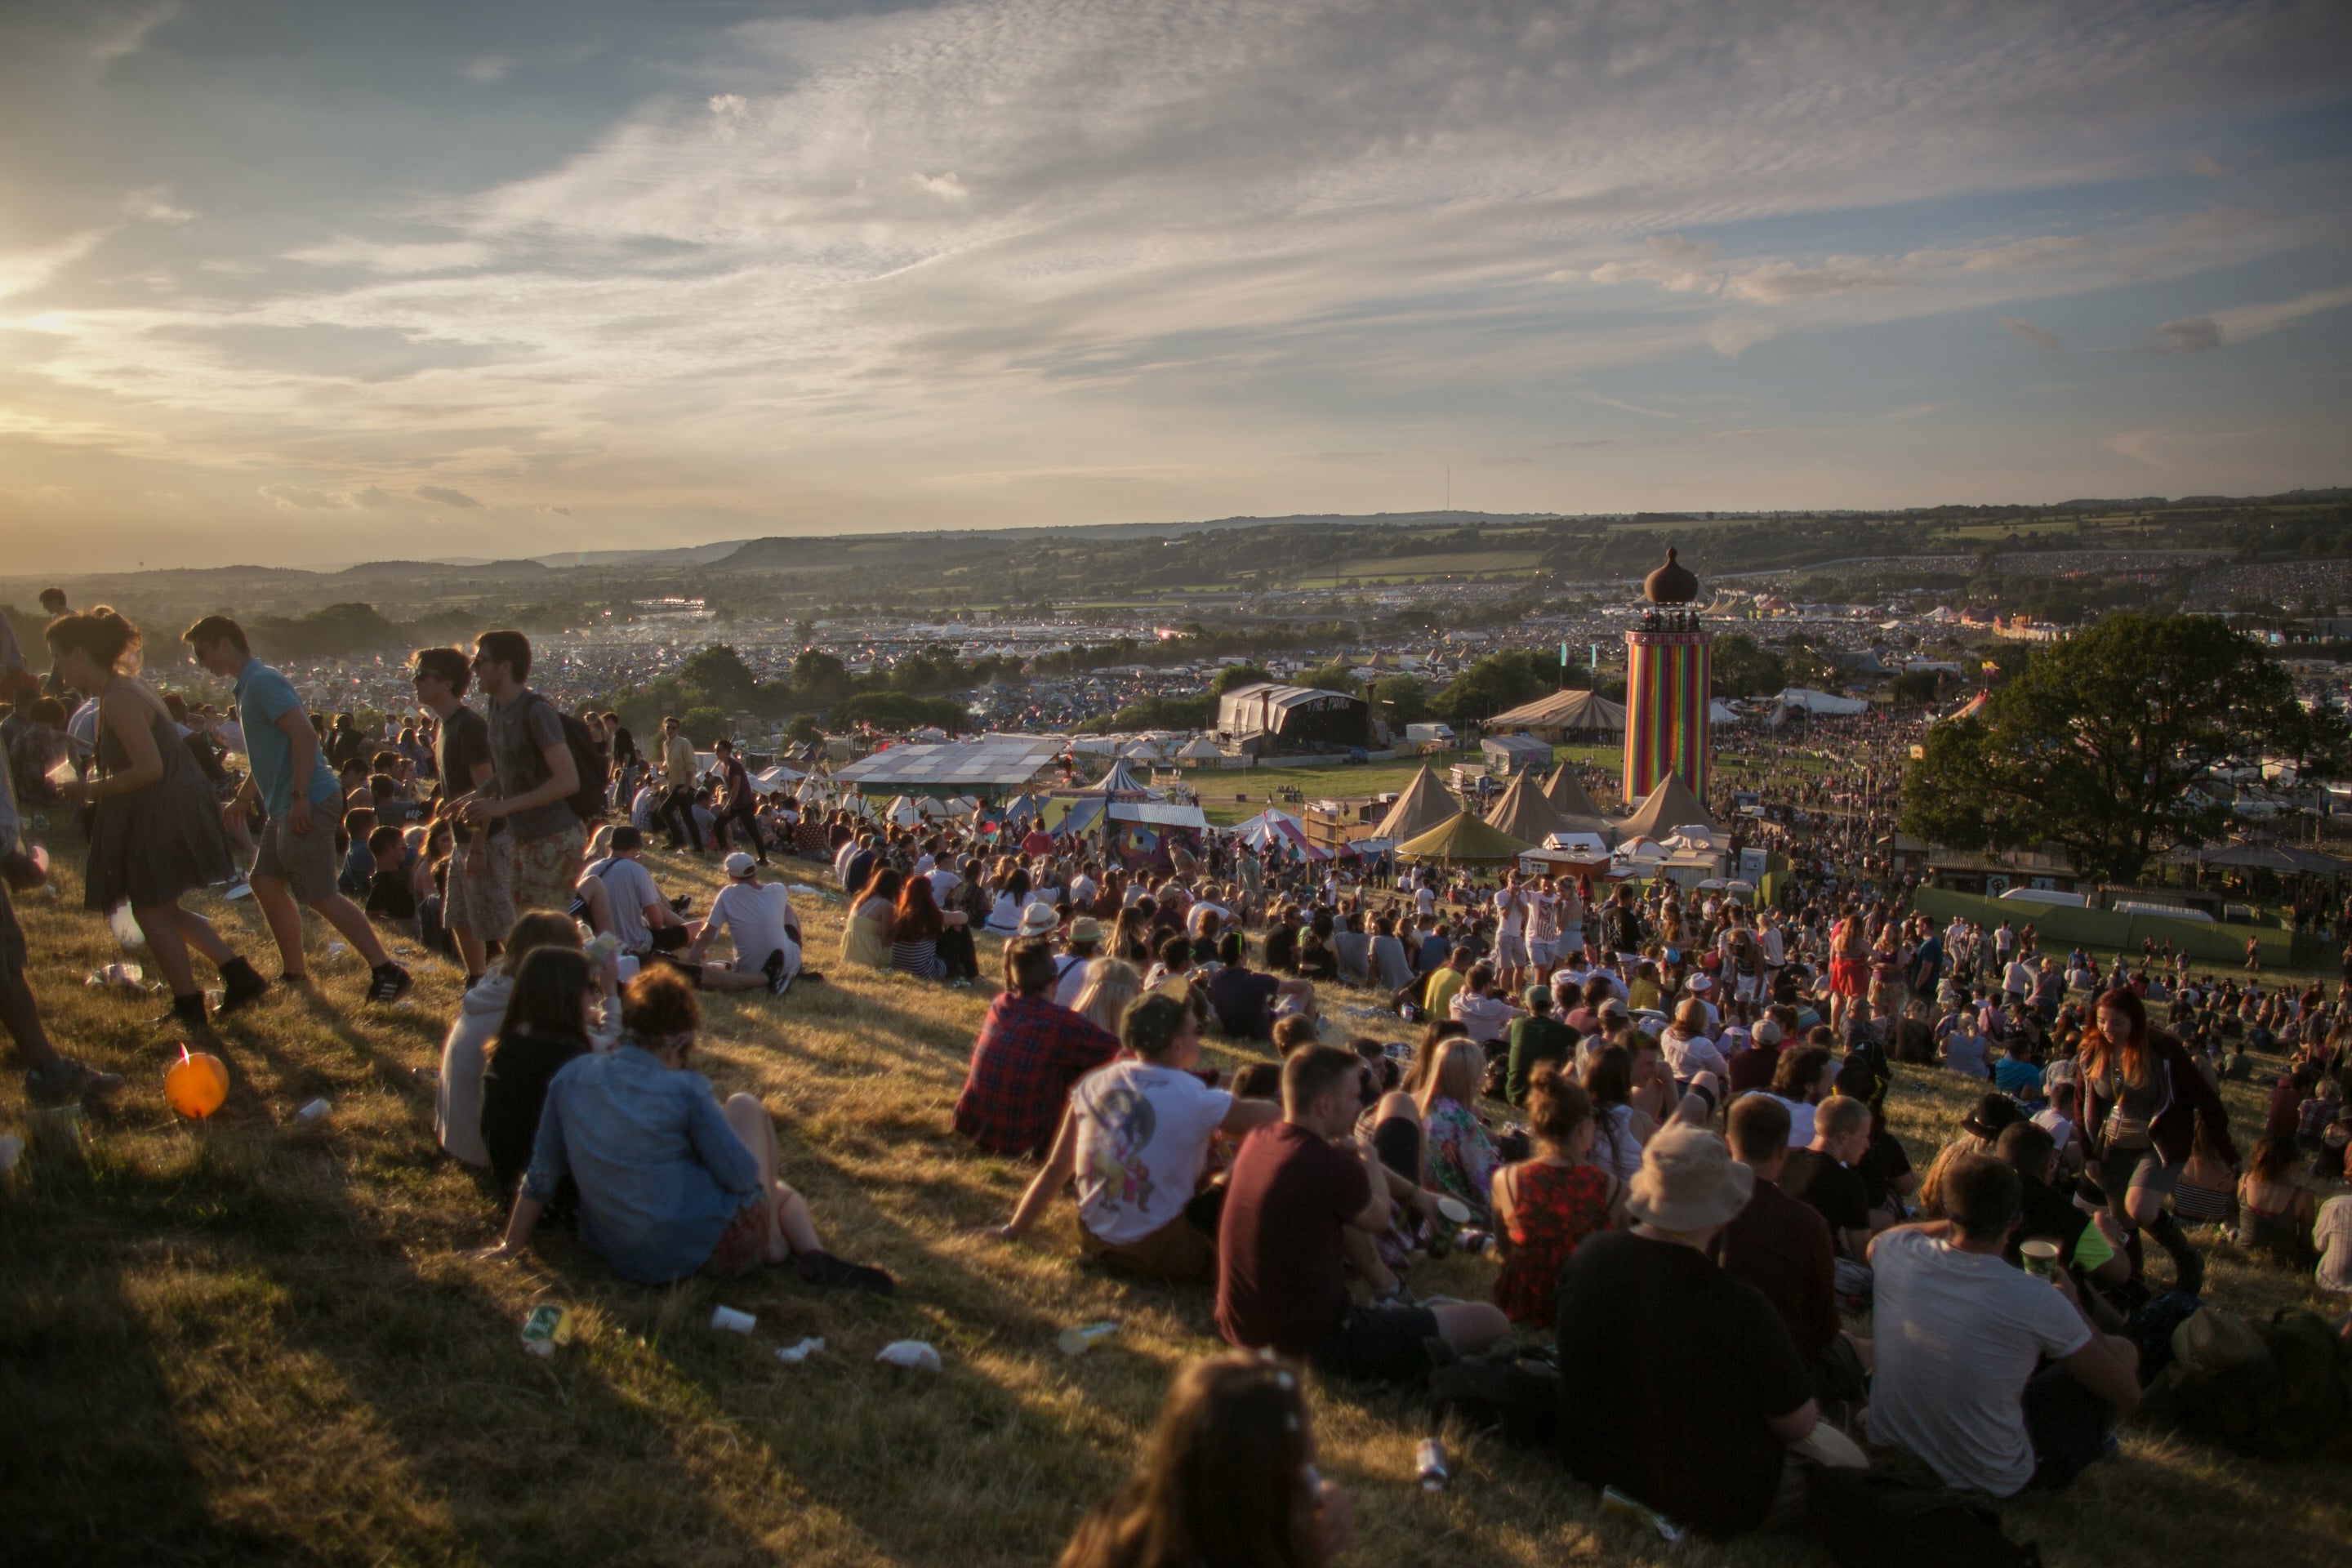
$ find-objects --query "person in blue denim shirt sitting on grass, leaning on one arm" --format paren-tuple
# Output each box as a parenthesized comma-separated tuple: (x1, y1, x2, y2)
(482, 969, 898, 1295)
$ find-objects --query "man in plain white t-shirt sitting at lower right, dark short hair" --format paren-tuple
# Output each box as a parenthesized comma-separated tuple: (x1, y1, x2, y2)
(1870, 1154, 2140, 1498)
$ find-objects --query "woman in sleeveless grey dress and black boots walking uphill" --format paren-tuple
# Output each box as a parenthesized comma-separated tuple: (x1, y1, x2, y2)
(45, 604, 268, 1025)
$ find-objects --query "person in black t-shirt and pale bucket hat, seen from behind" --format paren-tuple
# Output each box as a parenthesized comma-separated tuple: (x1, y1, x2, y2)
(1555, 1126, 1818, 1535)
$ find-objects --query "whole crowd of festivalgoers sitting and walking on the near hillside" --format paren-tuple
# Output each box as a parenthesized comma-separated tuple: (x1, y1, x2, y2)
(0, 597, 2352, 1563)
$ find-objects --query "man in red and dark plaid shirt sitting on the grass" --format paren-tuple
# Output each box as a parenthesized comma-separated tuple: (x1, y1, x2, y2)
(955, 940, 1120, 1159)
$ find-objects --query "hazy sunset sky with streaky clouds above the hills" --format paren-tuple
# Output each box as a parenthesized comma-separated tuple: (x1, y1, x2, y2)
(0, 0, 2352, 573)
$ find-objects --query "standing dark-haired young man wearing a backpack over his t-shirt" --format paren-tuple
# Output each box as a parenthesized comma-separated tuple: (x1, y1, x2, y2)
(459, 632, 588, 912)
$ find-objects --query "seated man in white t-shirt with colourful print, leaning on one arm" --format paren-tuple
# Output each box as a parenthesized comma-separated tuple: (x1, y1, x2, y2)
(997, 992, 1282, 1284)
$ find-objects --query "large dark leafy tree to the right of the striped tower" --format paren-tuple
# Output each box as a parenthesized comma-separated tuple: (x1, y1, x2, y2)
(1900, 613, 2347, 881)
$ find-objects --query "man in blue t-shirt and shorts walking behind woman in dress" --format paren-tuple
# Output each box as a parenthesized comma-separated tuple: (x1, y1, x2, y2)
(181, 616, 414, 1001)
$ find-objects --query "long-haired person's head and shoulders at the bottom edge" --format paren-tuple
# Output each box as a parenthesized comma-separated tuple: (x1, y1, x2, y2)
(1054, 1356, 1355, 1568)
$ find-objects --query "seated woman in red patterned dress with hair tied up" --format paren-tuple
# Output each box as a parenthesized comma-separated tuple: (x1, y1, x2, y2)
(1489, 1062, 1625, 1328)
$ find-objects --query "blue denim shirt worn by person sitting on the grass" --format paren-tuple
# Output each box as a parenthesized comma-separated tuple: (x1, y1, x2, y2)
(522, 1044, 760, 1284)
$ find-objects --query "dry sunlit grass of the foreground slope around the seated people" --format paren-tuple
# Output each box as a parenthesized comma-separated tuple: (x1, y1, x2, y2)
(0, 846, 2352, 1568)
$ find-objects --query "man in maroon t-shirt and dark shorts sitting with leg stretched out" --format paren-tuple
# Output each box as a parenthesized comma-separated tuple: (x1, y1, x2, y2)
(1216, 1046, 1510, 1383)
